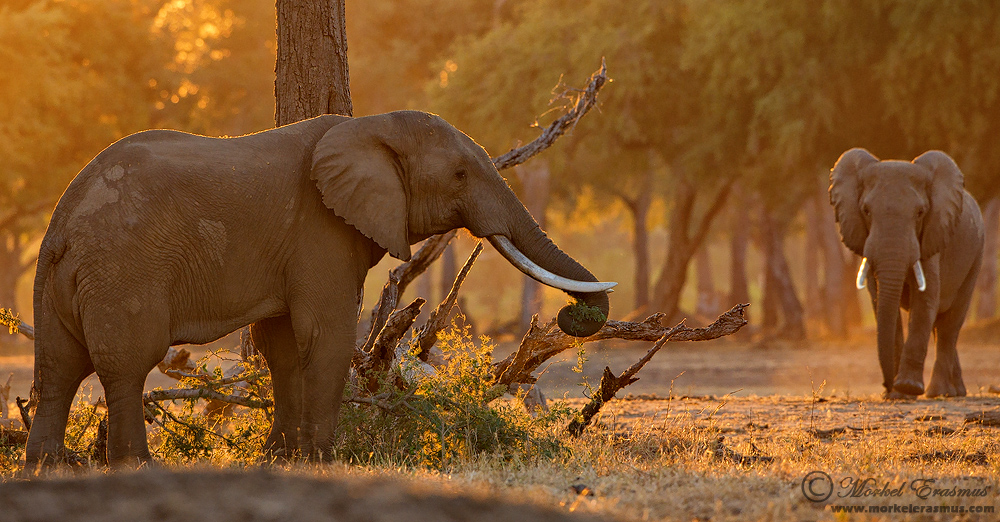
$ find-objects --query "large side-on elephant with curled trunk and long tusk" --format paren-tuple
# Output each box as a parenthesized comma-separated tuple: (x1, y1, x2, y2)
(26, 107, 615, 468)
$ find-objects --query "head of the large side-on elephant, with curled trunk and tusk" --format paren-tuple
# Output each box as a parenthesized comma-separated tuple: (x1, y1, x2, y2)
(311, 111, 615, 337)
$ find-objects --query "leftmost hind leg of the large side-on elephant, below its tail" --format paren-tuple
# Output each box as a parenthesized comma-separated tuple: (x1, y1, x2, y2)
(25, 307, 94, 473)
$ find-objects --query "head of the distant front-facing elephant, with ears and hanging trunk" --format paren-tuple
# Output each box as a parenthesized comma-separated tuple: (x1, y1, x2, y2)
(830, 148, 964, 389)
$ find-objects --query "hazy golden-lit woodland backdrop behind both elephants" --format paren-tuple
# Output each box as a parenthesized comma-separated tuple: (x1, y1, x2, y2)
(0, 0, 1000, 349)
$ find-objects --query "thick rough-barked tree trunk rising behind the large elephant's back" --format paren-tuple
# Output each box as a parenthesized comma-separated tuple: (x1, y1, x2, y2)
(274, 0, 353, 126)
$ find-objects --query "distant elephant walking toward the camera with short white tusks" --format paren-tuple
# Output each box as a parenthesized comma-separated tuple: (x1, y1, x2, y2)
(830, 149, 983, 398)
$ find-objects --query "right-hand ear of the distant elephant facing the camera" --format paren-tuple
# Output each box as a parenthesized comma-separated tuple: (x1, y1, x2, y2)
(913, 150, 965, 259)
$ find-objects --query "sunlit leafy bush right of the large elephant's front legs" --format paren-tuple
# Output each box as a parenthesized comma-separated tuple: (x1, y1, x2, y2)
(337, 327, 570, 470)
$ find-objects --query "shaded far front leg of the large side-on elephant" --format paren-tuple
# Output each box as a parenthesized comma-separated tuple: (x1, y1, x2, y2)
(250, 315, 302, 460)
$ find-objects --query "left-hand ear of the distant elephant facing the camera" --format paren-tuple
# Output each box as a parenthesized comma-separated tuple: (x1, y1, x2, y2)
(830, 148, 878, 256)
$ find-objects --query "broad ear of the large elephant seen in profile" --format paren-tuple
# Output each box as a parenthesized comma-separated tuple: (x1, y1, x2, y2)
(310, 115, 410, 261)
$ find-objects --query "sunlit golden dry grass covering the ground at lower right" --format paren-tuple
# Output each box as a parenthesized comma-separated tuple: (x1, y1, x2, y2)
(4, 396, 1000, 521)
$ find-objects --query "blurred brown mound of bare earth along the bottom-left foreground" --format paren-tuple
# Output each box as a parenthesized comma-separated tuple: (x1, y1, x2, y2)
(0, 470, 600, 522)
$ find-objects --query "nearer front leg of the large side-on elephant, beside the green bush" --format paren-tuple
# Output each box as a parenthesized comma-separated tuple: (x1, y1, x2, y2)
(295, 304, 356, 461)
